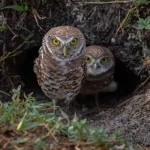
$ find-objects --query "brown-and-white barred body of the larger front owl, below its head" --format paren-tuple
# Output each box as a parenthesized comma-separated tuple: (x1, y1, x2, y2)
(34, 48, 85, 101)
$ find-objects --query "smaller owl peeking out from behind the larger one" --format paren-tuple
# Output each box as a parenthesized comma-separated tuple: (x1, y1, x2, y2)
(81, 45, 117, 95)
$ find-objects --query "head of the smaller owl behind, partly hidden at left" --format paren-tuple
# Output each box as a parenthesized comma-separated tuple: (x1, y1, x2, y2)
(85, 45, 115, 80)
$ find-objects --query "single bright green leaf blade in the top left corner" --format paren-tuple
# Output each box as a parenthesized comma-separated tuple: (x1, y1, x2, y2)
(1, 5, 28, 11)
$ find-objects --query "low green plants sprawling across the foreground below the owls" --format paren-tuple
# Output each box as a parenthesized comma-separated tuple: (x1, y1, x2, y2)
(0, 86, 134, 150)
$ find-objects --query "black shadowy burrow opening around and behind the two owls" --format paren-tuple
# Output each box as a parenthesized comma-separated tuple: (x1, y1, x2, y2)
(17, 47, 140, 107)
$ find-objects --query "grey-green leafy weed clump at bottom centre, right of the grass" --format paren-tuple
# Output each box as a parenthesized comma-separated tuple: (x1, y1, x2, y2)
(68, 119, 127, 147)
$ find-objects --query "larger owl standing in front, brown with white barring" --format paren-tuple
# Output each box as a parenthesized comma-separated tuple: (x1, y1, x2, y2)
(34, 26, 85, 108)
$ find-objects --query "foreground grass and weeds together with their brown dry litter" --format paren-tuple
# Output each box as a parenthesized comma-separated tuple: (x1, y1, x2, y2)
(0, 86, 138, 149)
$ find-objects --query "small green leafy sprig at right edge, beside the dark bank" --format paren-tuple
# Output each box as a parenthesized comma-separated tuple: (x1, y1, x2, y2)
(137, 16, 150, 30)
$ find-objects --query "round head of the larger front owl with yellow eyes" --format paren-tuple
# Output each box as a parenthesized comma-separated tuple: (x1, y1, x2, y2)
(43, 26, 85, 61)
